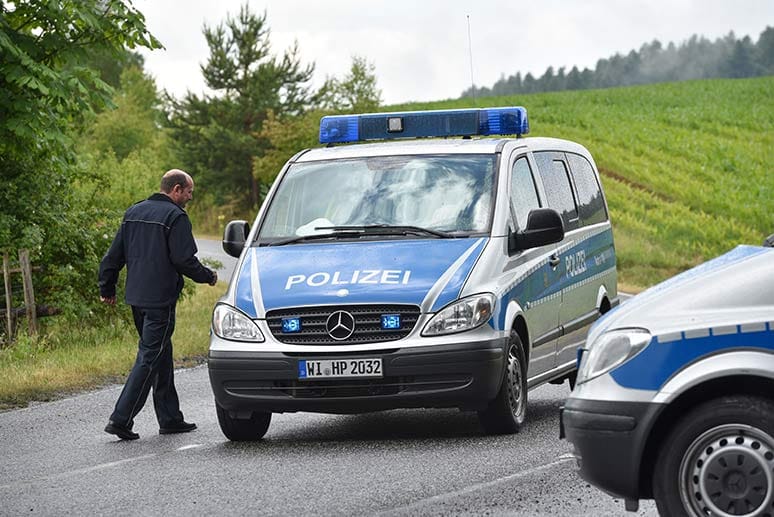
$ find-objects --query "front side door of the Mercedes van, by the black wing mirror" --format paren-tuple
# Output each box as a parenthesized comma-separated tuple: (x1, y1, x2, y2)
(509, 154, 561, 377)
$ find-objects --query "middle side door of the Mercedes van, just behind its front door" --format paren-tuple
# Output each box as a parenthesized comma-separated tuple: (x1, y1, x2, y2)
(534, 151, 580, 367)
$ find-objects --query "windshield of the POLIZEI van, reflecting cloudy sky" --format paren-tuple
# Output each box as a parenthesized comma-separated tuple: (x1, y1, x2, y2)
(258, 154, 495, 240)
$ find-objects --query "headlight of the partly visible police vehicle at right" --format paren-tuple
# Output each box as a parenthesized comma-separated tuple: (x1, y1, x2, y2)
(578, 329, 651, 384)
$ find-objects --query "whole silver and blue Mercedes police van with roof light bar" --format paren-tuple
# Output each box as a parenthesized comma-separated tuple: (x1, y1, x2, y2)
(208, 107, 618, 440)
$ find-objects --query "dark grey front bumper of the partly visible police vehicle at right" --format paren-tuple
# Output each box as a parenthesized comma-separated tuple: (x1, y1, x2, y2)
(560, 398, 664, 500)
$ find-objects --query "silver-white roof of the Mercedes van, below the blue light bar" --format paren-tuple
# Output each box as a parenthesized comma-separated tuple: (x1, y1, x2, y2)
(296, 137, 588, 162)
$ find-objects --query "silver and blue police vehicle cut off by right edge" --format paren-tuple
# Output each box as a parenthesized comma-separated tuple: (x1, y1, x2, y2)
(561, 241, 774, 517)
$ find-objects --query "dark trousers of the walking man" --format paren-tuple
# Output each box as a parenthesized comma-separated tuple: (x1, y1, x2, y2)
(110, 305, 183, 429)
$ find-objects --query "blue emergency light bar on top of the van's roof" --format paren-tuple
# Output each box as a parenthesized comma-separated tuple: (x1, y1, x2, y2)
(320, 106, 529, 144)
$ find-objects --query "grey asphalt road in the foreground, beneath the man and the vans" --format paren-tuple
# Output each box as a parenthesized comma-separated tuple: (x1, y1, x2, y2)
(0, 367, 656, 517)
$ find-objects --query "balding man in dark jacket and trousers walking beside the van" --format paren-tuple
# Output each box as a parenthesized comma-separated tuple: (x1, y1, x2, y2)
(99, 169, 218, 440)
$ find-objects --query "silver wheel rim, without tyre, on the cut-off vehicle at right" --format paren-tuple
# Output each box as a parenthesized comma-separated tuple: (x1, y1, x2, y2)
(680, 424, 774, 517)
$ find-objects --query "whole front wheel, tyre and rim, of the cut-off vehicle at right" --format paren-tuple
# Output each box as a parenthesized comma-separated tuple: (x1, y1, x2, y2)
(653, 395, 774, 517)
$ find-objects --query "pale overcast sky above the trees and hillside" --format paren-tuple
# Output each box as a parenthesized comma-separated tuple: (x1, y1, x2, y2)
(133, 0, 774, 104)
